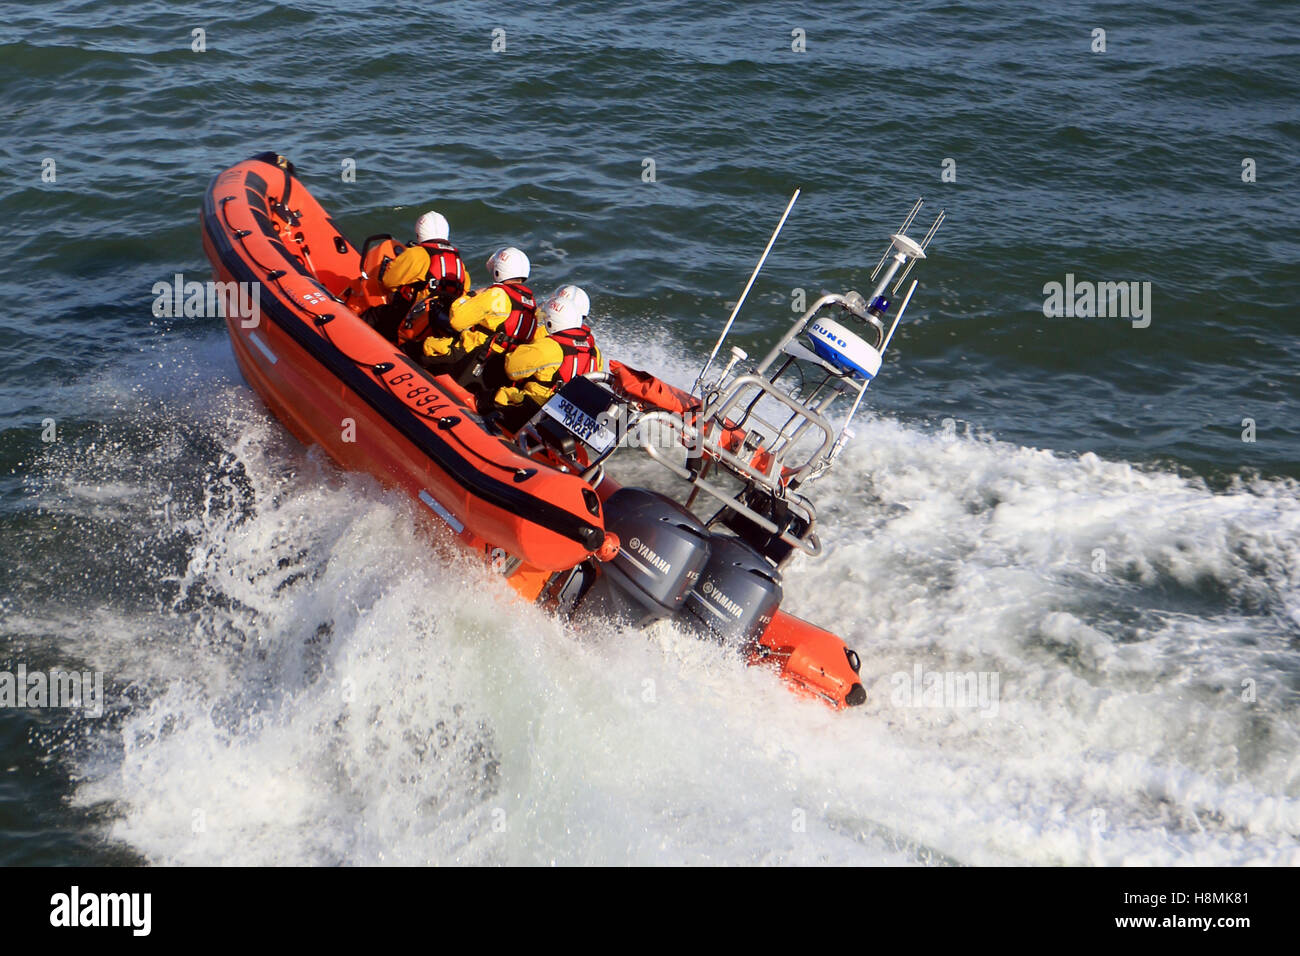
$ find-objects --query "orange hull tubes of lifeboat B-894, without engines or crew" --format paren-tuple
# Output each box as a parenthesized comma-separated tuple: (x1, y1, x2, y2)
(202, 153, 865, 708)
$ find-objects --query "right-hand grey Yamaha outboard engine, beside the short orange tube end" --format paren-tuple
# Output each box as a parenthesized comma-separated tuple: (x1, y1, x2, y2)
(683, 533, 783, 644)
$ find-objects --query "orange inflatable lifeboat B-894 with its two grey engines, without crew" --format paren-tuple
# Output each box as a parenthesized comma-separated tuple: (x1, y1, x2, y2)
(200, 153, 866, 708)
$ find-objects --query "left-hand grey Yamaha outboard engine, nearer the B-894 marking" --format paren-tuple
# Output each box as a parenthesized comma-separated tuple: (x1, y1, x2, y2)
(580, 488, 710, 627)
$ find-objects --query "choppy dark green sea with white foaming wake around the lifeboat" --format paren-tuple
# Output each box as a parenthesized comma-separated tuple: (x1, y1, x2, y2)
(0, 3, 1300, 865)
